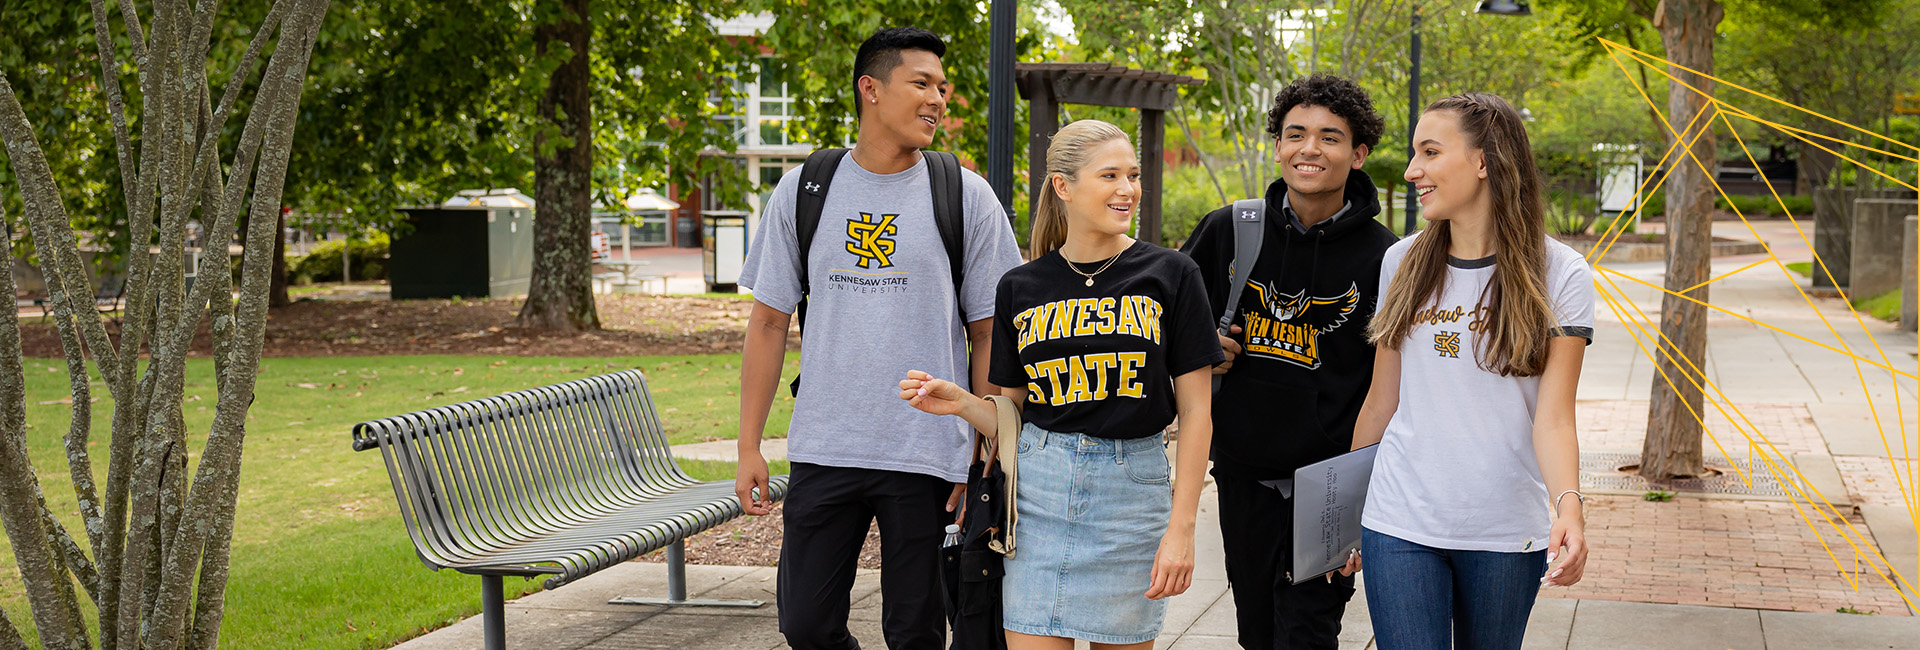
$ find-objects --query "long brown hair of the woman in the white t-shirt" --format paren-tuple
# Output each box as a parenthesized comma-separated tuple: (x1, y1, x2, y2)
(1367, 92, 1553, 378)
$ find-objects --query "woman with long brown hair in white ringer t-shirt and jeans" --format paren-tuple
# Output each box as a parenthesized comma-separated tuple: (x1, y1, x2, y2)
(1348, 92, 1594, 650)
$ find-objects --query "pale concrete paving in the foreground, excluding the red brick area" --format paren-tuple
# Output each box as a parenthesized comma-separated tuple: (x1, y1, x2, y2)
(396, 487, 1920, 650)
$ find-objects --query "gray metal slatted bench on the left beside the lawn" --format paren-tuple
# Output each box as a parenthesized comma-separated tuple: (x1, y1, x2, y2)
(353, 370, 787, 650)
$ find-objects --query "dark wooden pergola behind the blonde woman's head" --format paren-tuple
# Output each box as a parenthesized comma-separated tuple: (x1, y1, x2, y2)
(1014, 63, 1206, 244)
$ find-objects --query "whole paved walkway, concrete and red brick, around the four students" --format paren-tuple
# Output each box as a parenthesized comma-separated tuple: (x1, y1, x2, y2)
(399, 221, 1920, 650)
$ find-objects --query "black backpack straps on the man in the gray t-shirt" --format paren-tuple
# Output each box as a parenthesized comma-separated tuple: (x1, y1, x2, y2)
(787, 148, 966, 397)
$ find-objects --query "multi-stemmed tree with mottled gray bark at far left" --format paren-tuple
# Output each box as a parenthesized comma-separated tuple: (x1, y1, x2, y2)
(0, 0, 330, 650)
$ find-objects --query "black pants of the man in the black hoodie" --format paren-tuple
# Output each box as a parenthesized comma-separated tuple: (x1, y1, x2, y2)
(1213, 474, 1354, 650)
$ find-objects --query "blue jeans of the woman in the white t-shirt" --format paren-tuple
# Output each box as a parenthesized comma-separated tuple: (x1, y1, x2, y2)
(1359, 529, 1548, 650)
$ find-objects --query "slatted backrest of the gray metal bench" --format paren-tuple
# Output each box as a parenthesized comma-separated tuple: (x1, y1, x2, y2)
(353, 370, 695, 568)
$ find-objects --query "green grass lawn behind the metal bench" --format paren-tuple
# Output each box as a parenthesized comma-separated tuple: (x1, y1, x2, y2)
(0, 355, 799, 648)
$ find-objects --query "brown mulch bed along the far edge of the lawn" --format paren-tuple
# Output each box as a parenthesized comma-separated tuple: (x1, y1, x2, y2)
(21, 295, 799, 357)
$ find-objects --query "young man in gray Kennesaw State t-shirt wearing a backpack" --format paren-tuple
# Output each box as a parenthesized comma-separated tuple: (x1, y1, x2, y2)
(735, 27, 1020, 650)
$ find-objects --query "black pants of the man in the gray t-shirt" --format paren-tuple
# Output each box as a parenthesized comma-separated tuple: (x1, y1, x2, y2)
(778, 462, 954, 650)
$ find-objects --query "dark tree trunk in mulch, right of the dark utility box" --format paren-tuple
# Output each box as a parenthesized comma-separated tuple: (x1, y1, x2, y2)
(520, 0, 599, 330)
